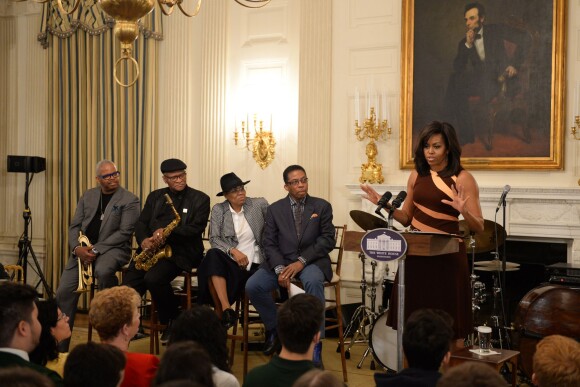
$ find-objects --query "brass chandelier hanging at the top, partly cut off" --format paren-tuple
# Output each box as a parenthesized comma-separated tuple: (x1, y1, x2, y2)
(12, 0, 272, 87)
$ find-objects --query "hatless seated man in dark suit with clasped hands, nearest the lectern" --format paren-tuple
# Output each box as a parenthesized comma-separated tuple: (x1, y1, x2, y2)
(246, 165, 335, 364)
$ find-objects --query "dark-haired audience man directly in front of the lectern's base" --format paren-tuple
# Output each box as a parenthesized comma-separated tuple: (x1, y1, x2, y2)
(375, 309, 453, 387)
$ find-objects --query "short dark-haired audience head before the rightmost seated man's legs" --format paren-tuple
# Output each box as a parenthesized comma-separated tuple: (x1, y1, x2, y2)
(277, 293, 324, 355)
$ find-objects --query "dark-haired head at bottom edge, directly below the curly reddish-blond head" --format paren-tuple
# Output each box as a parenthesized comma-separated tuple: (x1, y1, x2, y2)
(64, 341, 126, 387)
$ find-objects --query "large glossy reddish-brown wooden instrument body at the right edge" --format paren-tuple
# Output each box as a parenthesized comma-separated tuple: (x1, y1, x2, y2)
(513, 285, 580, 378)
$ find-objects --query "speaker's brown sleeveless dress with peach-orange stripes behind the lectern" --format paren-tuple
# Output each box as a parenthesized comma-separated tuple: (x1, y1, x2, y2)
(387, 171, 473, 338)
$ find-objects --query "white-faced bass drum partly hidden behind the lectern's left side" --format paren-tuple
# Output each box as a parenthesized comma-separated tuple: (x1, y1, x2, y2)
(369, 312, 398, 371)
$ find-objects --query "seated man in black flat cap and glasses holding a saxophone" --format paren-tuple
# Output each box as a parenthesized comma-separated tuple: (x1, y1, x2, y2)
(123, 159, 209, 343)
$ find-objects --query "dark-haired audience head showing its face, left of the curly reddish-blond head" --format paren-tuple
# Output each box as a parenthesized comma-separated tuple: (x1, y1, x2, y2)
(30, 299, 71, 365)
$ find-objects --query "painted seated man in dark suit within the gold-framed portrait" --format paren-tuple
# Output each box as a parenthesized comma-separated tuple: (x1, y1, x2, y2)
(445, 3, 530, 149)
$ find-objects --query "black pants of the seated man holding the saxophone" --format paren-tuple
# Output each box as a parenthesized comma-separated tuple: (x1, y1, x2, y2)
(123, 259, 183, 324)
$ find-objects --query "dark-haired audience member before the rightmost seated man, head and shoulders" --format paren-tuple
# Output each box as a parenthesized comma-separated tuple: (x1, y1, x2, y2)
(244, 293, 324, 387)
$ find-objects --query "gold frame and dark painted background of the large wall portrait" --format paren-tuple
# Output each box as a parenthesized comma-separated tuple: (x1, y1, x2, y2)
(400, 0, 567, 170)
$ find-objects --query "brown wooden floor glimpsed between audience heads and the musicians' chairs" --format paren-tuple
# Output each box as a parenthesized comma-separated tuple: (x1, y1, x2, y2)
(71, 314, 378, 387)
